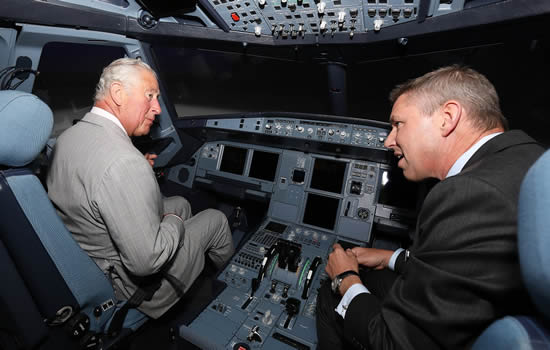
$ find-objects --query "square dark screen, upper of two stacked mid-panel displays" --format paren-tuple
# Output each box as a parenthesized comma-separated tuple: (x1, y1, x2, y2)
(310, 158, 348, 194)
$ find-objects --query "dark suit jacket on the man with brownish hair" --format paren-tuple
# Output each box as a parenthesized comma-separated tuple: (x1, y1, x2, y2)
(345, 131, 544, 350)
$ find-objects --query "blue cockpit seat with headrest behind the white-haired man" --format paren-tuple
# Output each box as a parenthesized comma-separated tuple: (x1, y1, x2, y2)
(0, 91, 147, 349)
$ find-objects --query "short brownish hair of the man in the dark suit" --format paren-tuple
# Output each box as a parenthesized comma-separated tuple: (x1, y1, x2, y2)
(390, 65, 508, 130)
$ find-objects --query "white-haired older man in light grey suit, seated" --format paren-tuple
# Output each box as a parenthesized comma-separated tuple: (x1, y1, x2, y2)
(47, 58, 234, 318)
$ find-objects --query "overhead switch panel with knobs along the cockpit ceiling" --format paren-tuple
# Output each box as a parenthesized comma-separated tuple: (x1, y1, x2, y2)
(208, 0, 464, 41)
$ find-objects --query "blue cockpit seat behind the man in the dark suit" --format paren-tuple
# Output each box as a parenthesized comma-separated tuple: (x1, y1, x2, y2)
(473, 151, 550, 350)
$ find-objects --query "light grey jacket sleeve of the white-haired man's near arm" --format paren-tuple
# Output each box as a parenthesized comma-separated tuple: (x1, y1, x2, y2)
(94, 155, 185, 276)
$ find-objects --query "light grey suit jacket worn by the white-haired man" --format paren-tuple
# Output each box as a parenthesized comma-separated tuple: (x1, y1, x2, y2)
(47, 113, 185, 316)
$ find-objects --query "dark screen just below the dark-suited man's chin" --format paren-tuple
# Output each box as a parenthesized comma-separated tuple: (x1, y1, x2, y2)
(378, 169, 418, 210)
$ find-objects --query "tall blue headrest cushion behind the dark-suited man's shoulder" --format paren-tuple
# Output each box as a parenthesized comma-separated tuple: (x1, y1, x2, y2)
(518, 151, 550, 318)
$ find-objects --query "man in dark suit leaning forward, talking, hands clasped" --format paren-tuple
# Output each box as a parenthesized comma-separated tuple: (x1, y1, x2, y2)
(317, 66, 544, 350)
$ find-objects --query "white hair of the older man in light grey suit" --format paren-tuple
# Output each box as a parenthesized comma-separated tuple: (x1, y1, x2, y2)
(94, 57, 157, 102)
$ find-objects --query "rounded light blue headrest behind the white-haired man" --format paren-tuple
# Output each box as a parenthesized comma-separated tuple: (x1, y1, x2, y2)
(0, 90, 53, 167)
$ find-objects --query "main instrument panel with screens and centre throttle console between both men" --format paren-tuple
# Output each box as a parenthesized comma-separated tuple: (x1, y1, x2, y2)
(175, 115, 411, 349)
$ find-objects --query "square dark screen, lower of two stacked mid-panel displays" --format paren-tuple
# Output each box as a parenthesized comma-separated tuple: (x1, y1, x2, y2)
(302, 193, 340, 230)
